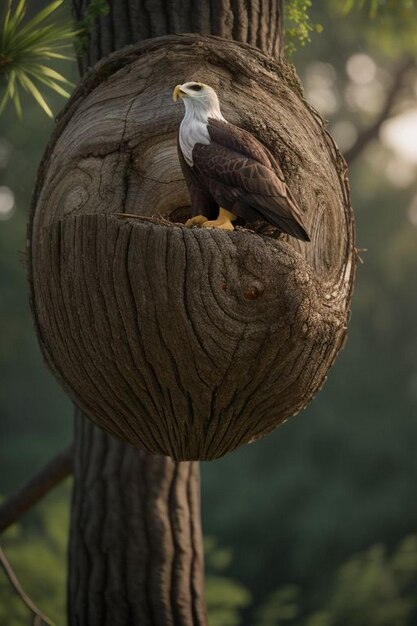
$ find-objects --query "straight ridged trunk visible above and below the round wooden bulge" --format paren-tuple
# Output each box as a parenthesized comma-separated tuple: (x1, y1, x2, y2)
(63, 0, 282, 626)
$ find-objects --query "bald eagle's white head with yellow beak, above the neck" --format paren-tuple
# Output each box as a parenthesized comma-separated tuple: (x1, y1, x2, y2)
(172, 82, 224, 122)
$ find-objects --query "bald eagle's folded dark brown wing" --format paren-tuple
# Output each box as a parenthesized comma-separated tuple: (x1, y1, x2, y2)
(192, 120, 309, 241)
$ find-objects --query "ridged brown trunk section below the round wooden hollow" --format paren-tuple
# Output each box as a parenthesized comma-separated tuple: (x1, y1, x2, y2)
(68, 414, 206, 626)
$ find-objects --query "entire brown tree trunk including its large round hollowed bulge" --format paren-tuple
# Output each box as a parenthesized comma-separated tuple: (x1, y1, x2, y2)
(29, 0, 354, 626)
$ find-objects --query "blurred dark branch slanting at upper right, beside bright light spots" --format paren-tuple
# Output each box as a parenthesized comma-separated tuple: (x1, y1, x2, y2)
(344, 57, 415, 165)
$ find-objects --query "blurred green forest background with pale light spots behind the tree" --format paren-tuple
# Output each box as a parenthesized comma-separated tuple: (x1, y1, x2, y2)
(0, 0, 417, 626)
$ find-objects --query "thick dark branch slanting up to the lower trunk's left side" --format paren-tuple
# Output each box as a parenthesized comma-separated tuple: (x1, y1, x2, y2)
(0, 444, 73, 533)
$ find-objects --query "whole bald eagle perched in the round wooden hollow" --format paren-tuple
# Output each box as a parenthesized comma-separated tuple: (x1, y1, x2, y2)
(173, 82, 310, 241)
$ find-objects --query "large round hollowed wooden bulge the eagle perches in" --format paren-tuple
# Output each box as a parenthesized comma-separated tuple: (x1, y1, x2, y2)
(30, 35, 354, 460)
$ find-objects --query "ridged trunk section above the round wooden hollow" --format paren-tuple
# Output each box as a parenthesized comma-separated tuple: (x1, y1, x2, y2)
(72, 0, 284, 71)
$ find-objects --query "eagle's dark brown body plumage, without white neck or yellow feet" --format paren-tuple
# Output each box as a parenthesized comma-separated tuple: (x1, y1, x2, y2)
(173, 83, 310, 241)
